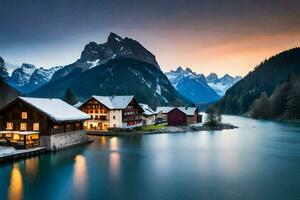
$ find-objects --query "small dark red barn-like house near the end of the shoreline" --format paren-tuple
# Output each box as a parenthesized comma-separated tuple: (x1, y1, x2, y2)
(168, 107, 199, 126)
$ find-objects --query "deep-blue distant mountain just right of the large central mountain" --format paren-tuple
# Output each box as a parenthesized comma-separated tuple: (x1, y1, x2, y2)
(166, 67, 220, 104)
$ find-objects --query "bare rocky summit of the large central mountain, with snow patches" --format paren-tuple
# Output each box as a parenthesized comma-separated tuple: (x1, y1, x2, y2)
(53, 33, 160, 80)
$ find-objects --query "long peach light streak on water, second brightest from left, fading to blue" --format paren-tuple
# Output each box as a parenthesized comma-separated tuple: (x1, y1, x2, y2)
(74, 155, 87, 195)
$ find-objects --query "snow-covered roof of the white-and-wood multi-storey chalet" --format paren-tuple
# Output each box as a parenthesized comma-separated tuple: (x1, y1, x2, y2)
(92, 96, 134, 110)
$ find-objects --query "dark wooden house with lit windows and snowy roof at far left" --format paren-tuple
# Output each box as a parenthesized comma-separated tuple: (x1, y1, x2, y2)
(0, 97, 90, 150)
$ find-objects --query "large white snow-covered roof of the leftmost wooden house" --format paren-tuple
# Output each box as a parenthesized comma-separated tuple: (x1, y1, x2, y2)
(19, 97, 90, 121)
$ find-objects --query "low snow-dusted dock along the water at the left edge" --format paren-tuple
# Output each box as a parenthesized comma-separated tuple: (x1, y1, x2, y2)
(0, 147, 46, 162)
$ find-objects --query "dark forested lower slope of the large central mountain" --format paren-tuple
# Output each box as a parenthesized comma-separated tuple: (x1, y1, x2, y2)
(31, 58, 186, 107)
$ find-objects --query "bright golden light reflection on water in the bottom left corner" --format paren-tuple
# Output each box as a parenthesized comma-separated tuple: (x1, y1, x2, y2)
(8, 164, 23, 200)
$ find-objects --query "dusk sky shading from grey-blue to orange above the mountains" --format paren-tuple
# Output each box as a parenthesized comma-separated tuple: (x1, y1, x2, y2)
(0, 0, 300, 75)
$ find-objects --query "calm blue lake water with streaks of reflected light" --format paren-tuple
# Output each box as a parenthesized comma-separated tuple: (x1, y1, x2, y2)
(0, 116, 300, 200)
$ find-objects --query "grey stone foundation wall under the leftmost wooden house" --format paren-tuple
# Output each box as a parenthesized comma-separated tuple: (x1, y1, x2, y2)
(40, 130, 88, 151)
